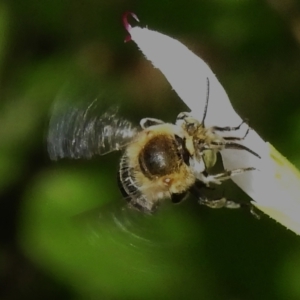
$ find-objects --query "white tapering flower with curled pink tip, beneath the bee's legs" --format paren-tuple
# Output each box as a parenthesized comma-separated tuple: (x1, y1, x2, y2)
(124, 15, 300, 234)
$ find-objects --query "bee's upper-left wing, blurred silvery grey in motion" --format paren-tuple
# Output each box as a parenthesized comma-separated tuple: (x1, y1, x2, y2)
(47, 99, 138, 160)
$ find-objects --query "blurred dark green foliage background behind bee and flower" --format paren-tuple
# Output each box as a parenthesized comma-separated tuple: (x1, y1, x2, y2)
(0, 0, 300, 300)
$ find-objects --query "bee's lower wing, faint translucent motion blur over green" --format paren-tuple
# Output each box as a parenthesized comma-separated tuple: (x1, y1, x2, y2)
(73, 199, 174, 251)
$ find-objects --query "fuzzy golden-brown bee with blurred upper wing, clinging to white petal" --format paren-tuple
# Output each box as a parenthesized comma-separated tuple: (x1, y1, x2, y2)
(48, 78, 260, 214)
